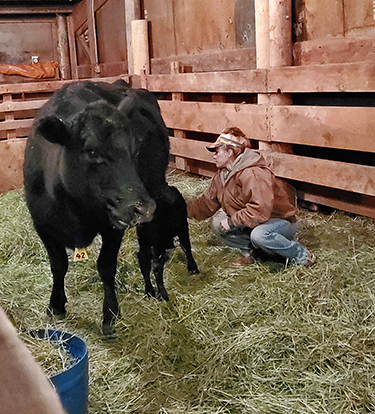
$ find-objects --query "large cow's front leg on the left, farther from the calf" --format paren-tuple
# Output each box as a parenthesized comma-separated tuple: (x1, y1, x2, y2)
(41, 236, 68, 318)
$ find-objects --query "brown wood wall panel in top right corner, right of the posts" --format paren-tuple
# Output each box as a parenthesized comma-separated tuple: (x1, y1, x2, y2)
(293, 0, 375, 65)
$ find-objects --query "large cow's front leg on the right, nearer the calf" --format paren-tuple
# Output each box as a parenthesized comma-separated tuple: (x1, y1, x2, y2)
(97, 231, 124, 335)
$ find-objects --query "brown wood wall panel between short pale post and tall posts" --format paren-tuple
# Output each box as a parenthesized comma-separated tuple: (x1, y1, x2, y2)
(144, 0, 255, 74)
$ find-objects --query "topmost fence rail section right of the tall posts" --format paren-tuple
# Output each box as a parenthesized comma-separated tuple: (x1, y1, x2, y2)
(268, 62, 375, 93)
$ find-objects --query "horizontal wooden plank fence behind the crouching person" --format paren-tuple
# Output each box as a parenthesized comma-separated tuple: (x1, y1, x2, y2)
(147, 61, 375, 217)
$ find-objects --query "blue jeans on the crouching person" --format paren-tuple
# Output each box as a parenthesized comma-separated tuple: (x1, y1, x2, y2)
(211, 210, 308, 265)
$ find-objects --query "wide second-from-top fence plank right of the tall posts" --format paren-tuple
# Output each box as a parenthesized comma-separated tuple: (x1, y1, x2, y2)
(269, 106, 375, 152)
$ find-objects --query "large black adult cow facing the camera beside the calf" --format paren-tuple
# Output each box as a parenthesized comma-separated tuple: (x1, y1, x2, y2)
(24, 81, 169, 334)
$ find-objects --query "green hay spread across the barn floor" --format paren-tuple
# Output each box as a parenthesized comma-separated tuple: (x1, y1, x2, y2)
(0, 172, 375, 414)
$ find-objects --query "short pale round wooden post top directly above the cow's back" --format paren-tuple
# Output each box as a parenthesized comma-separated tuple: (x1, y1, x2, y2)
(131, 20, 150, 75)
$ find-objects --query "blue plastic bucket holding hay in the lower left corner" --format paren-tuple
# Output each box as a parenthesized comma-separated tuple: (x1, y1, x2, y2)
(31, 329, 89, 414)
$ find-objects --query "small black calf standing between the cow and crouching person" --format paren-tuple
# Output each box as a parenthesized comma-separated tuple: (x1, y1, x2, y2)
(137, 186, 199, 300)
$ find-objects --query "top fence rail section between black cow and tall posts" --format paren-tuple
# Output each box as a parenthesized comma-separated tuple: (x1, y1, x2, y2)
(147, 70, 267, 93)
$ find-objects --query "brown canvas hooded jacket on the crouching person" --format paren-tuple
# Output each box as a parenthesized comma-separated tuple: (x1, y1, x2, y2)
(188, 149, 297, 228)
